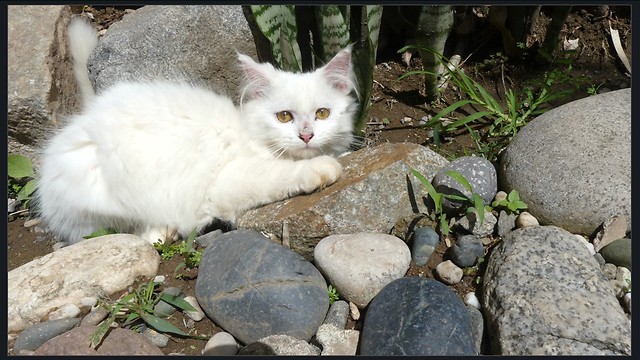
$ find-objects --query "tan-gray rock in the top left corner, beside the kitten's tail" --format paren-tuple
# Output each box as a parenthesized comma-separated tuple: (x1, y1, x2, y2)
(7, 5, 79, 163)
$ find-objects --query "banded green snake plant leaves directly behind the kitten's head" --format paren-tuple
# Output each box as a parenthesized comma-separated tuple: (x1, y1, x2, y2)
(242, 5, 383, 136)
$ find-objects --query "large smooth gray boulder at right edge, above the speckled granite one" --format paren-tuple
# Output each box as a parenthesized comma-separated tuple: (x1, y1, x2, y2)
(498, 89, 631, 235)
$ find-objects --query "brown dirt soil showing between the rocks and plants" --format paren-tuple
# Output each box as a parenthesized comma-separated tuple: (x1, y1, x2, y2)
(7, 6, 631, 355)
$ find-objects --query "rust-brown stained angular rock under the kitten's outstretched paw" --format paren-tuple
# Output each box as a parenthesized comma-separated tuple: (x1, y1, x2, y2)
(238, 143, 448, 260)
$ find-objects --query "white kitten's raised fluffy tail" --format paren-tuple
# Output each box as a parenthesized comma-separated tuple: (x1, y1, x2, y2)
(68, 17, 98, 104)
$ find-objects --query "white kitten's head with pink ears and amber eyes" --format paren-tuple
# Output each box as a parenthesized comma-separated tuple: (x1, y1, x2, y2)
(241, 49, 357, 159)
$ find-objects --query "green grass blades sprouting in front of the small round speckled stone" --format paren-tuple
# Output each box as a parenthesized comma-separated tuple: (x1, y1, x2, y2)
(411, 168, 487, 236)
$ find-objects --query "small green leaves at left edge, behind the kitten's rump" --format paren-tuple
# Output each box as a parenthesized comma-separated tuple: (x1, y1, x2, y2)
(7, 154, 38, 208)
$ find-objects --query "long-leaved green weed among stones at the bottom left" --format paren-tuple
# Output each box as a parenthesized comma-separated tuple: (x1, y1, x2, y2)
(90, 280, 204, 348)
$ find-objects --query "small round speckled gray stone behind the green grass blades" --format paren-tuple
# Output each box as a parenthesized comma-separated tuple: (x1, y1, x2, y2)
(431, 156, 498, 214)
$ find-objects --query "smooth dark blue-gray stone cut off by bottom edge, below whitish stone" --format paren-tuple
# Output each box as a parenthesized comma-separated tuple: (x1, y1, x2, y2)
(360, 276, 477, 356)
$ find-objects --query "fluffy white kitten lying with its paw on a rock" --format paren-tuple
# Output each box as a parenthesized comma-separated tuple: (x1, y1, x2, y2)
(36, 19, 357, 243)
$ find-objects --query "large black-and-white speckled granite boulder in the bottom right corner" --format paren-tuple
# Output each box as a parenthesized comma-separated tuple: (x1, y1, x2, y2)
(482, 226, 631, 355)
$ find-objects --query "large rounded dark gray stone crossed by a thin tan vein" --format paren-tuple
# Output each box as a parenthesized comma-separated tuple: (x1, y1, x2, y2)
(195, 230, 329, 344)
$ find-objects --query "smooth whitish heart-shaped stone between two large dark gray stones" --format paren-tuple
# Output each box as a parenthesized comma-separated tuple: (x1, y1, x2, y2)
(313, 233, 411, 309)
